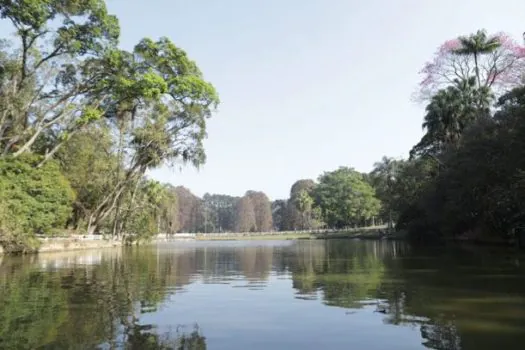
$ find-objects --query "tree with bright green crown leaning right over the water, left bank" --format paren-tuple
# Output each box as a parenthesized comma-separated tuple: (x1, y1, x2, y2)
(79, 38, 219, 235)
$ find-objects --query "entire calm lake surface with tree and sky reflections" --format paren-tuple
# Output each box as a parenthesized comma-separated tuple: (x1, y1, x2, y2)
(0, 240, 525, 350)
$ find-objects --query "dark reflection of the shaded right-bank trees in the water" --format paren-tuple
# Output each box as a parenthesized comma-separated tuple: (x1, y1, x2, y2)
(382, 248, 525, 350)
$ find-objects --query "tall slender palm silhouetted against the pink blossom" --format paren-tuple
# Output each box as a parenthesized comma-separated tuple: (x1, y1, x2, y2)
(454, 30, 501, 88)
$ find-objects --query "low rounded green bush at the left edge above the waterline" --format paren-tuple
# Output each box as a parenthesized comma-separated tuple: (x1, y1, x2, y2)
(0, 156, 74, 241)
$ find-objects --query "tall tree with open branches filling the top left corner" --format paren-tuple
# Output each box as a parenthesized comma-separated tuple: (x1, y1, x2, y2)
(0, 0, 120, 159)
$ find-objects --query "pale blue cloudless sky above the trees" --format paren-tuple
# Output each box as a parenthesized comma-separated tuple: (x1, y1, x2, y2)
(4, 0, 525, 199)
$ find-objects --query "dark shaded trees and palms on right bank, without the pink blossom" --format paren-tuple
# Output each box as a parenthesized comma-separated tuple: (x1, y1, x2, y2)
(381, 31, 525, 242)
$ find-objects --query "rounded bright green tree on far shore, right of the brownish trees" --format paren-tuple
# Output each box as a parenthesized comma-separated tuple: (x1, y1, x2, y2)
(314, 167, 380, 228)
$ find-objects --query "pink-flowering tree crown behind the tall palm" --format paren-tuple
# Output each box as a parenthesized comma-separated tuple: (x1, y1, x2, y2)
(415, 30, 525, 101)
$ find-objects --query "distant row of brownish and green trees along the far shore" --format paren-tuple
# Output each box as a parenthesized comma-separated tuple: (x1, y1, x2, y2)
(167, 167, 385, 233)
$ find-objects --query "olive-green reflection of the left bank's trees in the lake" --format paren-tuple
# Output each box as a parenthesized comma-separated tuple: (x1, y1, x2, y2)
(0, 249, 199, 349)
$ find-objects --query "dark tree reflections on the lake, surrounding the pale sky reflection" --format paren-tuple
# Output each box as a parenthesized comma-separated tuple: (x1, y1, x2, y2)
(0, 240, 525, 350)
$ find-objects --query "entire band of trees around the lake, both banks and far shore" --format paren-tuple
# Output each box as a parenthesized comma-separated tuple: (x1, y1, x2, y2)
(0, 0, 525, 246)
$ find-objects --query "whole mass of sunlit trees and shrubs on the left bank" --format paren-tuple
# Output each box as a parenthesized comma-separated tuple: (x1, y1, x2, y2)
(0, 0, 219, 250)
